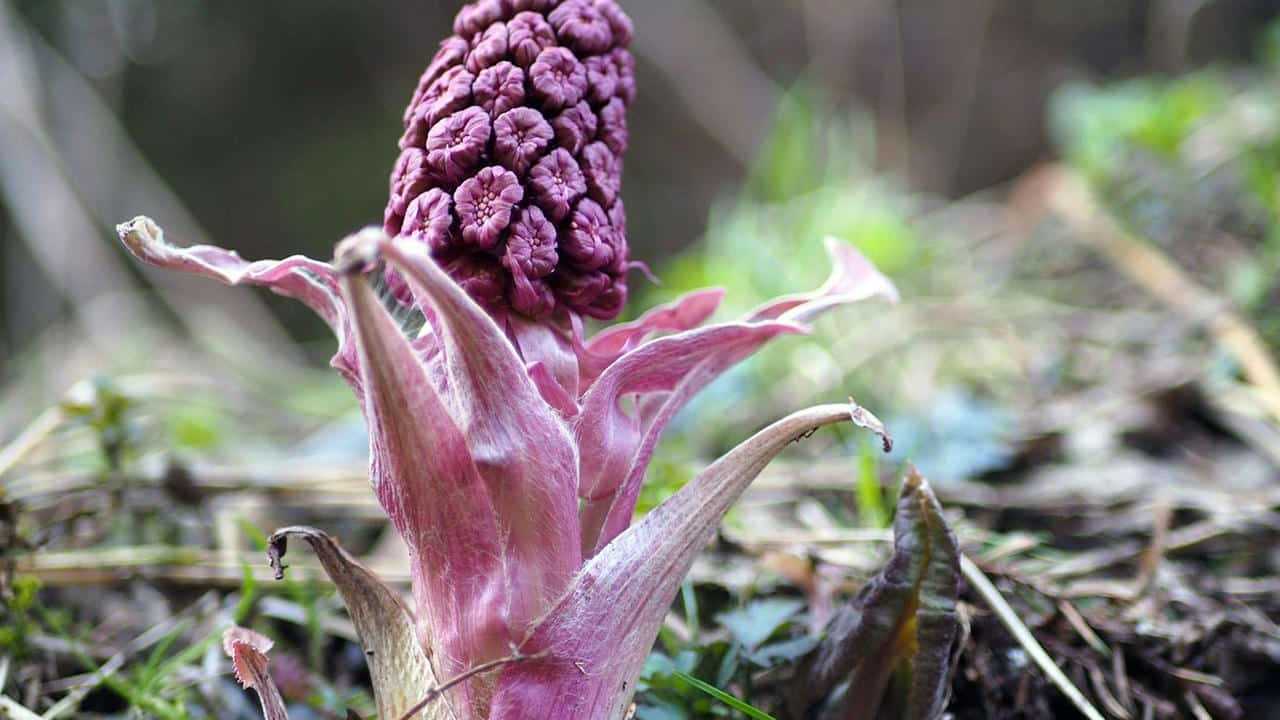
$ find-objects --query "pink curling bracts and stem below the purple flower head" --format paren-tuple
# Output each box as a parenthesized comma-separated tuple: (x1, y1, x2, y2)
(119, 213, 896, 720)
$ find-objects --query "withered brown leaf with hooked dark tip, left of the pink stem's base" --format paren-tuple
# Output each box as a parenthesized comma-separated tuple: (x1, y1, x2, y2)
(269, 527, 453, 720)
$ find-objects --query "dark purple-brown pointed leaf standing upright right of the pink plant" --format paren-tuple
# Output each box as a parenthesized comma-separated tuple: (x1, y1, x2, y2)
(788, 469, 960, 720)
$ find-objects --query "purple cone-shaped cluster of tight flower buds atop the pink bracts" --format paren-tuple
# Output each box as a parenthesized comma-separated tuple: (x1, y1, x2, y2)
(383, 0, 635, 319)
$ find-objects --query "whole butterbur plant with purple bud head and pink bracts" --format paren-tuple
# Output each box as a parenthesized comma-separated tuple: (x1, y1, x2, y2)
(119, 0, 911, 720)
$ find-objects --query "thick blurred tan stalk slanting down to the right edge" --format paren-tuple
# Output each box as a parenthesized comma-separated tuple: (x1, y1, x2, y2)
(1048, 169, 1280, 423)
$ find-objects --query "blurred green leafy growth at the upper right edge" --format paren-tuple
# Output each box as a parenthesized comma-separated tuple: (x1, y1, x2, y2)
(1050, 23, 1280, 348)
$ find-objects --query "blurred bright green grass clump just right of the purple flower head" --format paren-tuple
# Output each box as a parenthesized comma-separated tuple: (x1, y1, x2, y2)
(655, 85, 925, 310)
